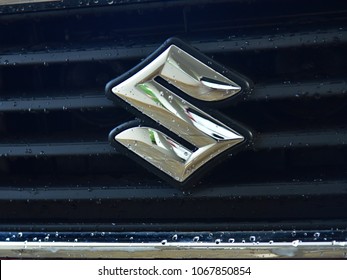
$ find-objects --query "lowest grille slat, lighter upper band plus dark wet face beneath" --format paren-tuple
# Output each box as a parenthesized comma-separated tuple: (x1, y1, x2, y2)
(0, 181, 347, 223)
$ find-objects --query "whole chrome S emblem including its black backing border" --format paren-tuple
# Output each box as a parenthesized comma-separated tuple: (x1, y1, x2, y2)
(106, 38, 252, 187)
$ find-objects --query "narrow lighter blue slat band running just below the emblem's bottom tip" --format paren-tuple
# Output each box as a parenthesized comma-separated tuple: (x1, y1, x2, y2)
(0, 180, 347, 201)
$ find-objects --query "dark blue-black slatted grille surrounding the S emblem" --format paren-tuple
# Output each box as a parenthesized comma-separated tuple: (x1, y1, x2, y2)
(0, 1, 347, 230)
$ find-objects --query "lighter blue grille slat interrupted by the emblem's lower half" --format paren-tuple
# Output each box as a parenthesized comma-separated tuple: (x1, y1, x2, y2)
(0, 129, 347, 157)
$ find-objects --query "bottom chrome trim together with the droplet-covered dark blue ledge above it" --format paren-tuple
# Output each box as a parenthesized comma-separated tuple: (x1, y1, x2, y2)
(0, 229, 347, 259)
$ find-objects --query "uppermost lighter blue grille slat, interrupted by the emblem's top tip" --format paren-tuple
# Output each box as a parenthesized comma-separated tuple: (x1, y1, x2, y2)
(0, 26, 347, 66)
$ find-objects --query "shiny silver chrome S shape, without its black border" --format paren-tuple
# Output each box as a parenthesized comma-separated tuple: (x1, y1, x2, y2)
(112, 45, 244, 182)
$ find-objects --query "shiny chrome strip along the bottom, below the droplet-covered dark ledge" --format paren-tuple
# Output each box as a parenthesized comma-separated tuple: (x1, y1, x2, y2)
(0, 241, 347, 259)
